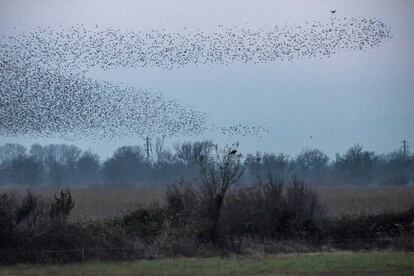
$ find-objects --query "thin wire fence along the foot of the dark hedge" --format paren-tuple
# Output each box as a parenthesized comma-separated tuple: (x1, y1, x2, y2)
(0, 237, 414, 263)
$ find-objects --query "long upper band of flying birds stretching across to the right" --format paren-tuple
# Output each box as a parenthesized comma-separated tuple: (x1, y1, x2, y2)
(4, 18, 391, 71)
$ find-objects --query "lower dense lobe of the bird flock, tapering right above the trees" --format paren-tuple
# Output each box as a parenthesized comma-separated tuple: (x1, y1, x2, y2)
(0, 61, 207, 138)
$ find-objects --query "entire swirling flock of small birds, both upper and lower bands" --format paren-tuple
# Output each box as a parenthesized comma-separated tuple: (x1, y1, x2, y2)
(0, 15, 392, 138)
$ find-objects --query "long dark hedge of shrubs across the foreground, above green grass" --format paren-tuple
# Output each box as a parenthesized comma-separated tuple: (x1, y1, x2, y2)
(0, 185, 414, 263)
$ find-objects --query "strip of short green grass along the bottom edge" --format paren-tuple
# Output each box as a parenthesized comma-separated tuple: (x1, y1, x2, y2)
(0, 252, 414, 275)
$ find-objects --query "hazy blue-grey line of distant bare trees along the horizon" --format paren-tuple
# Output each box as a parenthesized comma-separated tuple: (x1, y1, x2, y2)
(0, 139, 414, 187)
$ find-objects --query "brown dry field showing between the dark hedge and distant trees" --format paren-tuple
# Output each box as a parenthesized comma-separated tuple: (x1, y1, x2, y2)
(0, 186, 414, 221)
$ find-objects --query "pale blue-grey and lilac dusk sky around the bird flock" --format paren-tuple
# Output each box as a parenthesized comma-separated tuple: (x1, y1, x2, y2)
(0, 0, 414, 157)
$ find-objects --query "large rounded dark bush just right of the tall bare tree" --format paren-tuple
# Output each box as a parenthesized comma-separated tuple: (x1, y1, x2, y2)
(223, 181, 321, 239)
